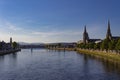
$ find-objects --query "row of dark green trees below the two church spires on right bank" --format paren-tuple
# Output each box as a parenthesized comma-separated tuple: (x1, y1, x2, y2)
(77, 38, 120, 51)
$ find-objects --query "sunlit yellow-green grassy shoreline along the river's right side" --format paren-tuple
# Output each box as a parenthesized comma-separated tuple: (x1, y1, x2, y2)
(50, 48, 120, 64)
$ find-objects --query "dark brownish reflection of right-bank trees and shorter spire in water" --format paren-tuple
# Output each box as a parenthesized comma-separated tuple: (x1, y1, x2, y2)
(78, 53, 120, 74)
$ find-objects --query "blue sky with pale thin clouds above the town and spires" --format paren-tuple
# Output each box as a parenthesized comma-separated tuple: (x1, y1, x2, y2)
(0, 0, 120, 43)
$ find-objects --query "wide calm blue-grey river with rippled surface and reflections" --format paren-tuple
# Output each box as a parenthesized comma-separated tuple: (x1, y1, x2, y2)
(0, 49, 120, 80)
